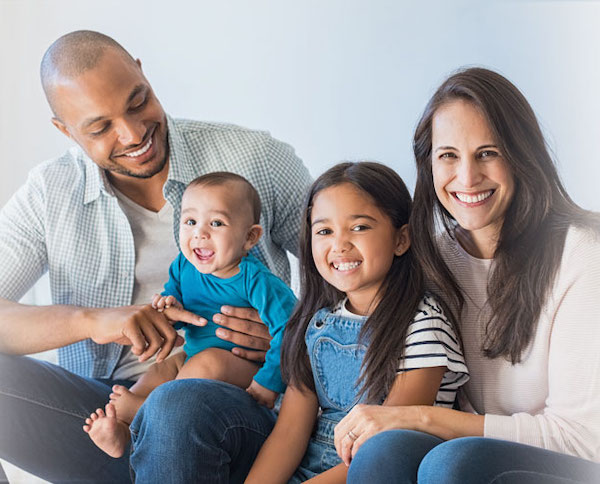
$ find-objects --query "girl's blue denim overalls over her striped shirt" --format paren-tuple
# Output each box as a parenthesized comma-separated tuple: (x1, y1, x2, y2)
(289, 309, 367, 484)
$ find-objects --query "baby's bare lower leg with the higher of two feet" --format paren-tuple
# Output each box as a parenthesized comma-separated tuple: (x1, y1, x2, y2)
(110, 352, 185, 424)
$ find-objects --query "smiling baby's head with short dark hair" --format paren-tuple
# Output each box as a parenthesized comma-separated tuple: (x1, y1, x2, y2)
(179, 172, 262, 278)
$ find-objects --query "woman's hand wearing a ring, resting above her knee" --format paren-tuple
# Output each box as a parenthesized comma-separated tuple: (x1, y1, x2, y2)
(334, 405, 421, 466)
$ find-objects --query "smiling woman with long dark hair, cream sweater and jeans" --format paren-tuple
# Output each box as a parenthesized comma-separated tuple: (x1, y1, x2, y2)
(335, 68, 600, 484)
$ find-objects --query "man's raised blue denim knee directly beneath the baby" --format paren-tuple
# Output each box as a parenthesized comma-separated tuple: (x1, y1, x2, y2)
(130, 379, 275, 484)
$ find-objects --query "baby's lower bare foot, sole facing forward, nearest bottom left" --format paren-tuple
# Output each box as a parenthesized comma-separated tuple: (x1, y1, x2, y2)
(83, 403, 131, 459)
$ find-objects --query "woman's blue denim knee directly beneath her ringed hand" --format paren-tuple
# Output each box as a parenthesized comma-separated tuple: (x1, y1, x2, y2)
(348, 430, 442, 483)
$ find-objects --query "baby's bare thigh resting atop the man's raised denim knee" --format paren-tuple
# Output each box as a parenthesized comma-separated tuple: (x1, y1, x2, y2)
(177, 348, 260, 390)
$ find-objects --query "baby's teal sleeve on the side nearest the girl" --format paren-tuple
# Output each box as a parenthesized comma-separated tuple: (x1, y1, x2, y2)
(248, 271, 296, 393)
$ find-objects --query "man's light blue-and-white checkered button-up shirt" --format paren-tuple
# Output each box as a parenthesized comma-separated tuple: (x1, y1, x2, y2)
(0, 118, 311, 378)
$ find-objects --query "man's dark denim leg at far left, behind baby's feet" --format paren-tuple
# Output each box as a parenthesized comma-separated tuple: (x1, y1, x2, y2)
(0, 353, 132, 483)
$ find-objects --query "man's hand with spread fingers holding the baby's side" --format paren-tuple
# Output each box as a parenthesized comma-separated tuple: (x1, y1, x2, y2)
(214, 306, 273, 363)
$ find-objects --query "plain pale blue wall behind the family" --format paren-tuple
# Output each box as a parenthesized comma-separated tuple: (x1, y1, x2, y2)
(0, 0, 600, 210)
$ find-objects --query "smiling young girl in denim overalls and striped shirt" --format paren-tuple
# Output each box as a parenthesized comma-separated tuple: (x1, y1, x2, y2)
(246, 162, 468, 483)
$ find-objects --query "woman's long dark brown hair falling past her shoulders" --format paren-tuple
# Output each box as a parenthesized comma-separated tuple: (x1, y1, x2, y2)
(412, 68, 600, 364)
